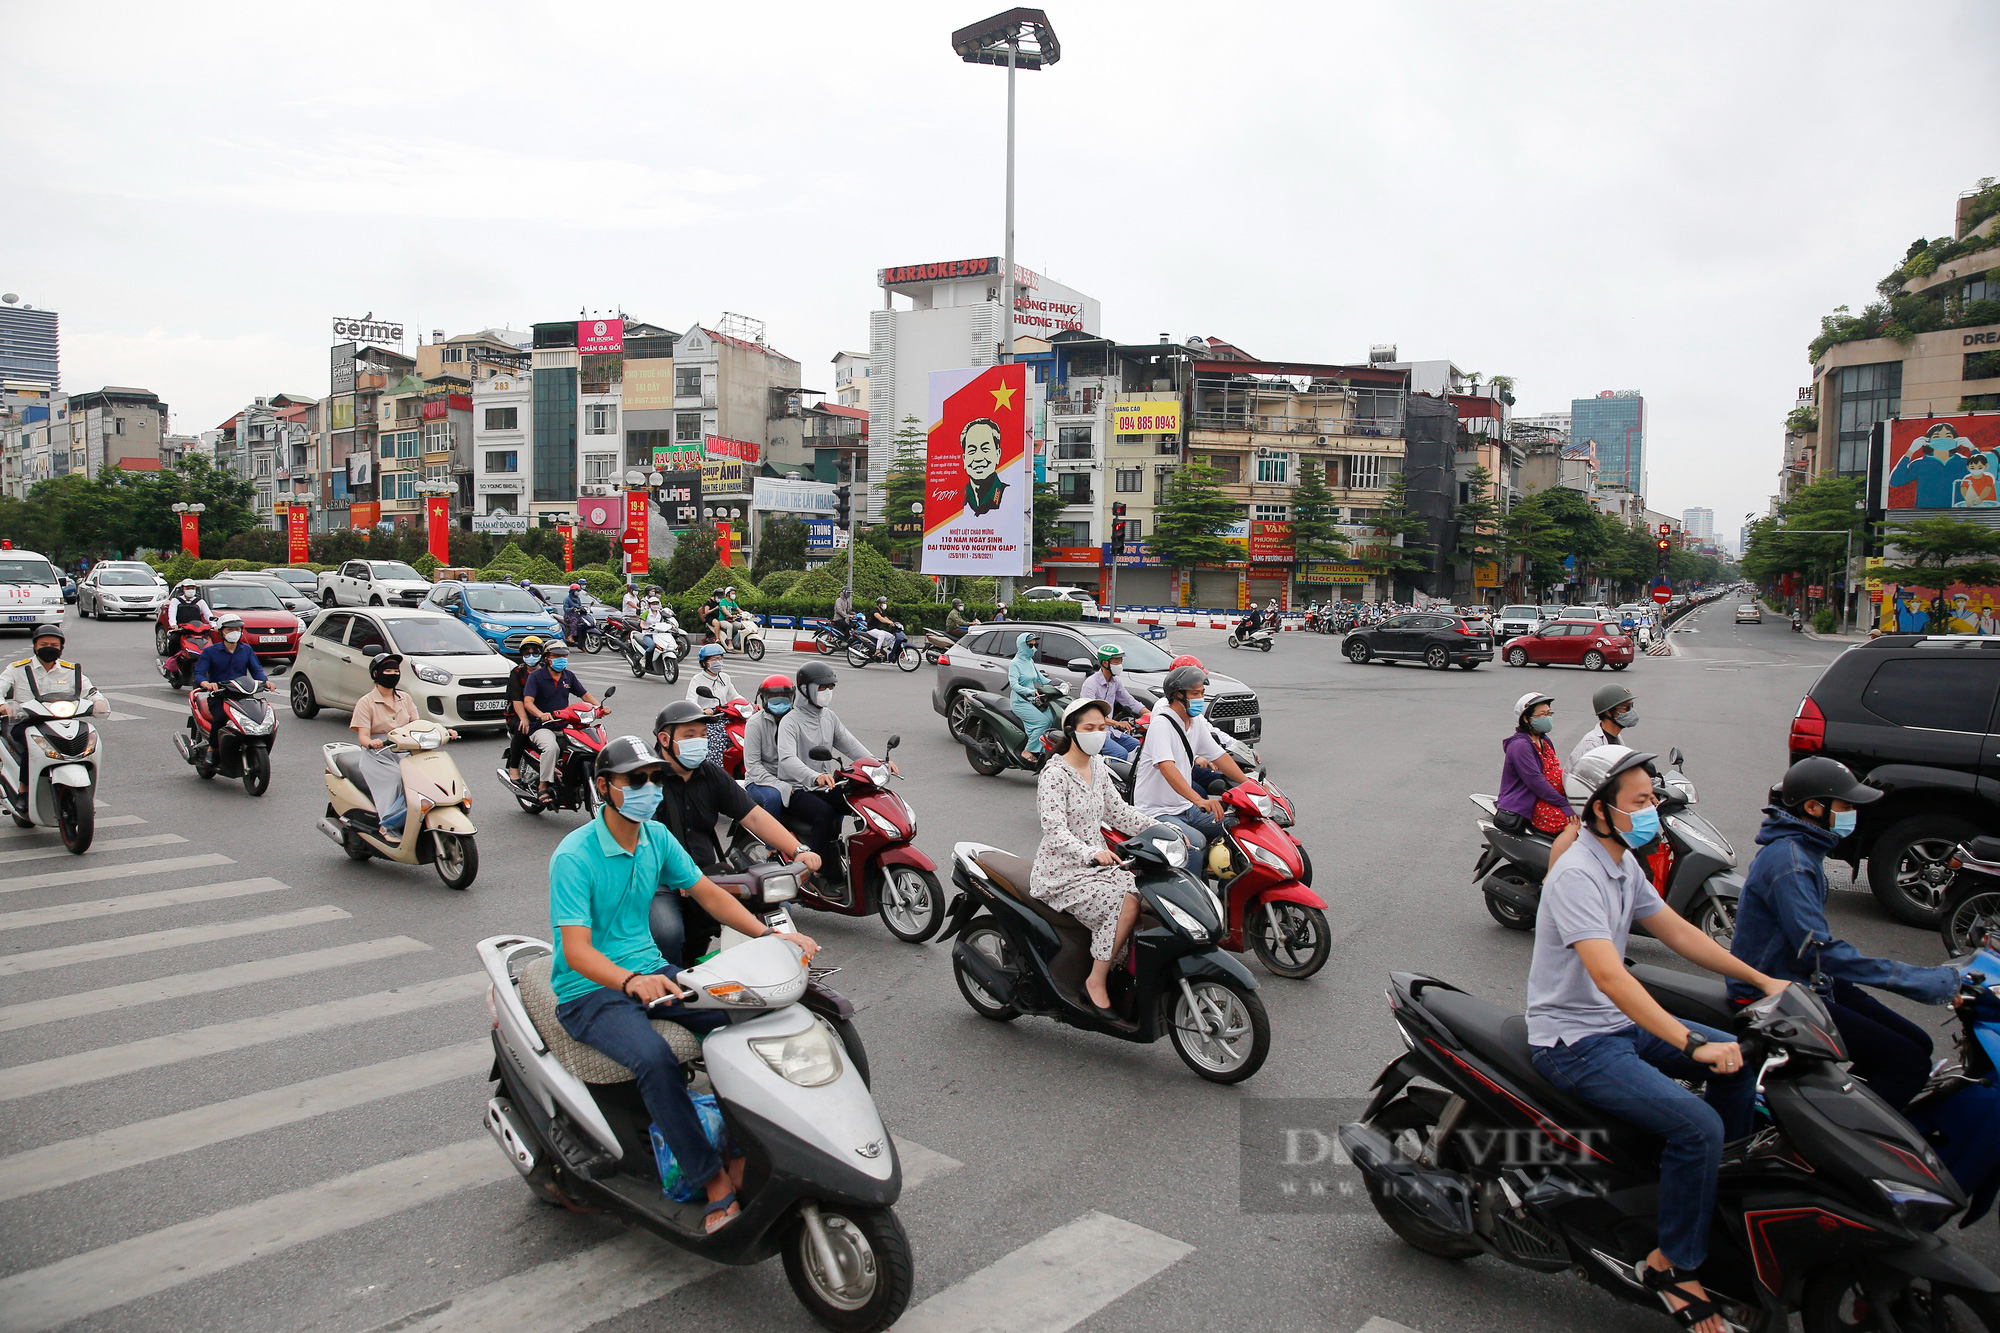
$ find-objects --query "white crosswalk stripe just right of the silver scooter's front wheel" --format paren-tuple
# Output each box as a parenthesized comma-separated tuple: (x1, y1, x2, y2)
(896, 1213, 1194, 1333)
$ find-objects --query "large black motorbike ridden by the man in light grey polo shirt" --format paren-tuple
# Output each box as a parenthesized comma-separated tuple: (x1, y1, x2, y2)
(1338, 969, 2000, 1333)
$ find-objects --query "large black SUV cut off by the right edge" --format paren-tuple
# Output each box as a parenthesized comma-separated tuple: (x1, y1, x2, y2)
(1790, 634, 2000, 927)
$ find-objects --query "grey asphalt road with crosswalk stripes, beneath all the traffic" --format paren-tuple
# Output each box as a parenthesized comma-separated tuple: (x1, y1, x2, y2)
(0, 602, 2000, 1333)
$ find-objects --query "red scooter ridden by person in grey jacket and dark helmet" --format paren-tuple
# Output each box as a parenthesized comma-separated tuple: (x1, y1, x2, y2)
(728, 737, 944, 945)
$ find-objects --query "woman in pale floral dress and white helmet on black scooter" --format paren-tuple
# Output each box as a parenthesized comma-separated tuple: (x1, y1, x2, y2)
(1028, 699, 1154, 1021)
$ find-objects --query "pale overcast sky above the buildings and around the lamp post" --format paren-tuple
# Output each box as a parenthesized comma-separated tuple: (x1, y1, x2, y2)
(0, 0, 2000, 536)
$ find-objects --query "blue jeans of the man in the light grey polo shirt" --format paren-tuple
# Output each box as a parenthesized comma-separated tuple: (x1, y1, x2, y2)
(1532, 1023, 1756, 1269)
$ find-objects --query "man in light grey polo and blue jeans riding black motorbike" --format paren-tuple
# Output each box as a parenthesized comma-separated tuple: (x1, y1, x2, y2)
(1528, 745, 1788, 1333)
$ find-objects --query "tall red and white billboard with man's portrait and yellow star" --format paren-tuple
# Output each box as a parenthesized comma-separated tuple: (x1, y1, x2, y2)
(922, 362, 1032, 576)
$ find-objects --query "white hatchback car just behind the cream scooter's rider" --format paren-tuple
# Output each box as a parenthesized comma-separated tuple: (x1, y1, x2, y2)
(292, 606, 514, 731)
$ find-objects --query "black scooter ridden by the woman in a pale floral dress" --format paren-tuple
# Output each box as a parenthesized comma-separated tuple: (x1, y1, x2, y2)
(944, 825, 1270, 1083)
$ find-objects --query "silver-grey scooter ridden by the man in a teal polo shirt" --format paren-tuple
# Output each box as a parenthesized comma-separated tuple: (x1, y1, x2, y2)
(478, 920, 912, 1333)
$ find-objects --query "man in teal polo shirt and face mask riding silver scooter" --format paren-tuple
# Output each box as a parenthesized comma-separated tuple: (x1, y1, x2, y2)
(548, 737, 820, 1231)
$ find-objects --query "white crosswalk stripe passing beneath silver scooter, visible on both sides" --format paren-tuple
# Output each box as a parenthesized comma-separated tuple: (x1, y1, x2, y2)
(364, 1139, 960, 1333)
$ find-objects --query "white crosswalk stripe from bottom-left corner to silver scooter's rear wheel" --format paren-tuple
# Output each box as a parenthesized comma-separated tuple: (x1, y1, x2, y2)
(0, 1135, 514, 1333)
